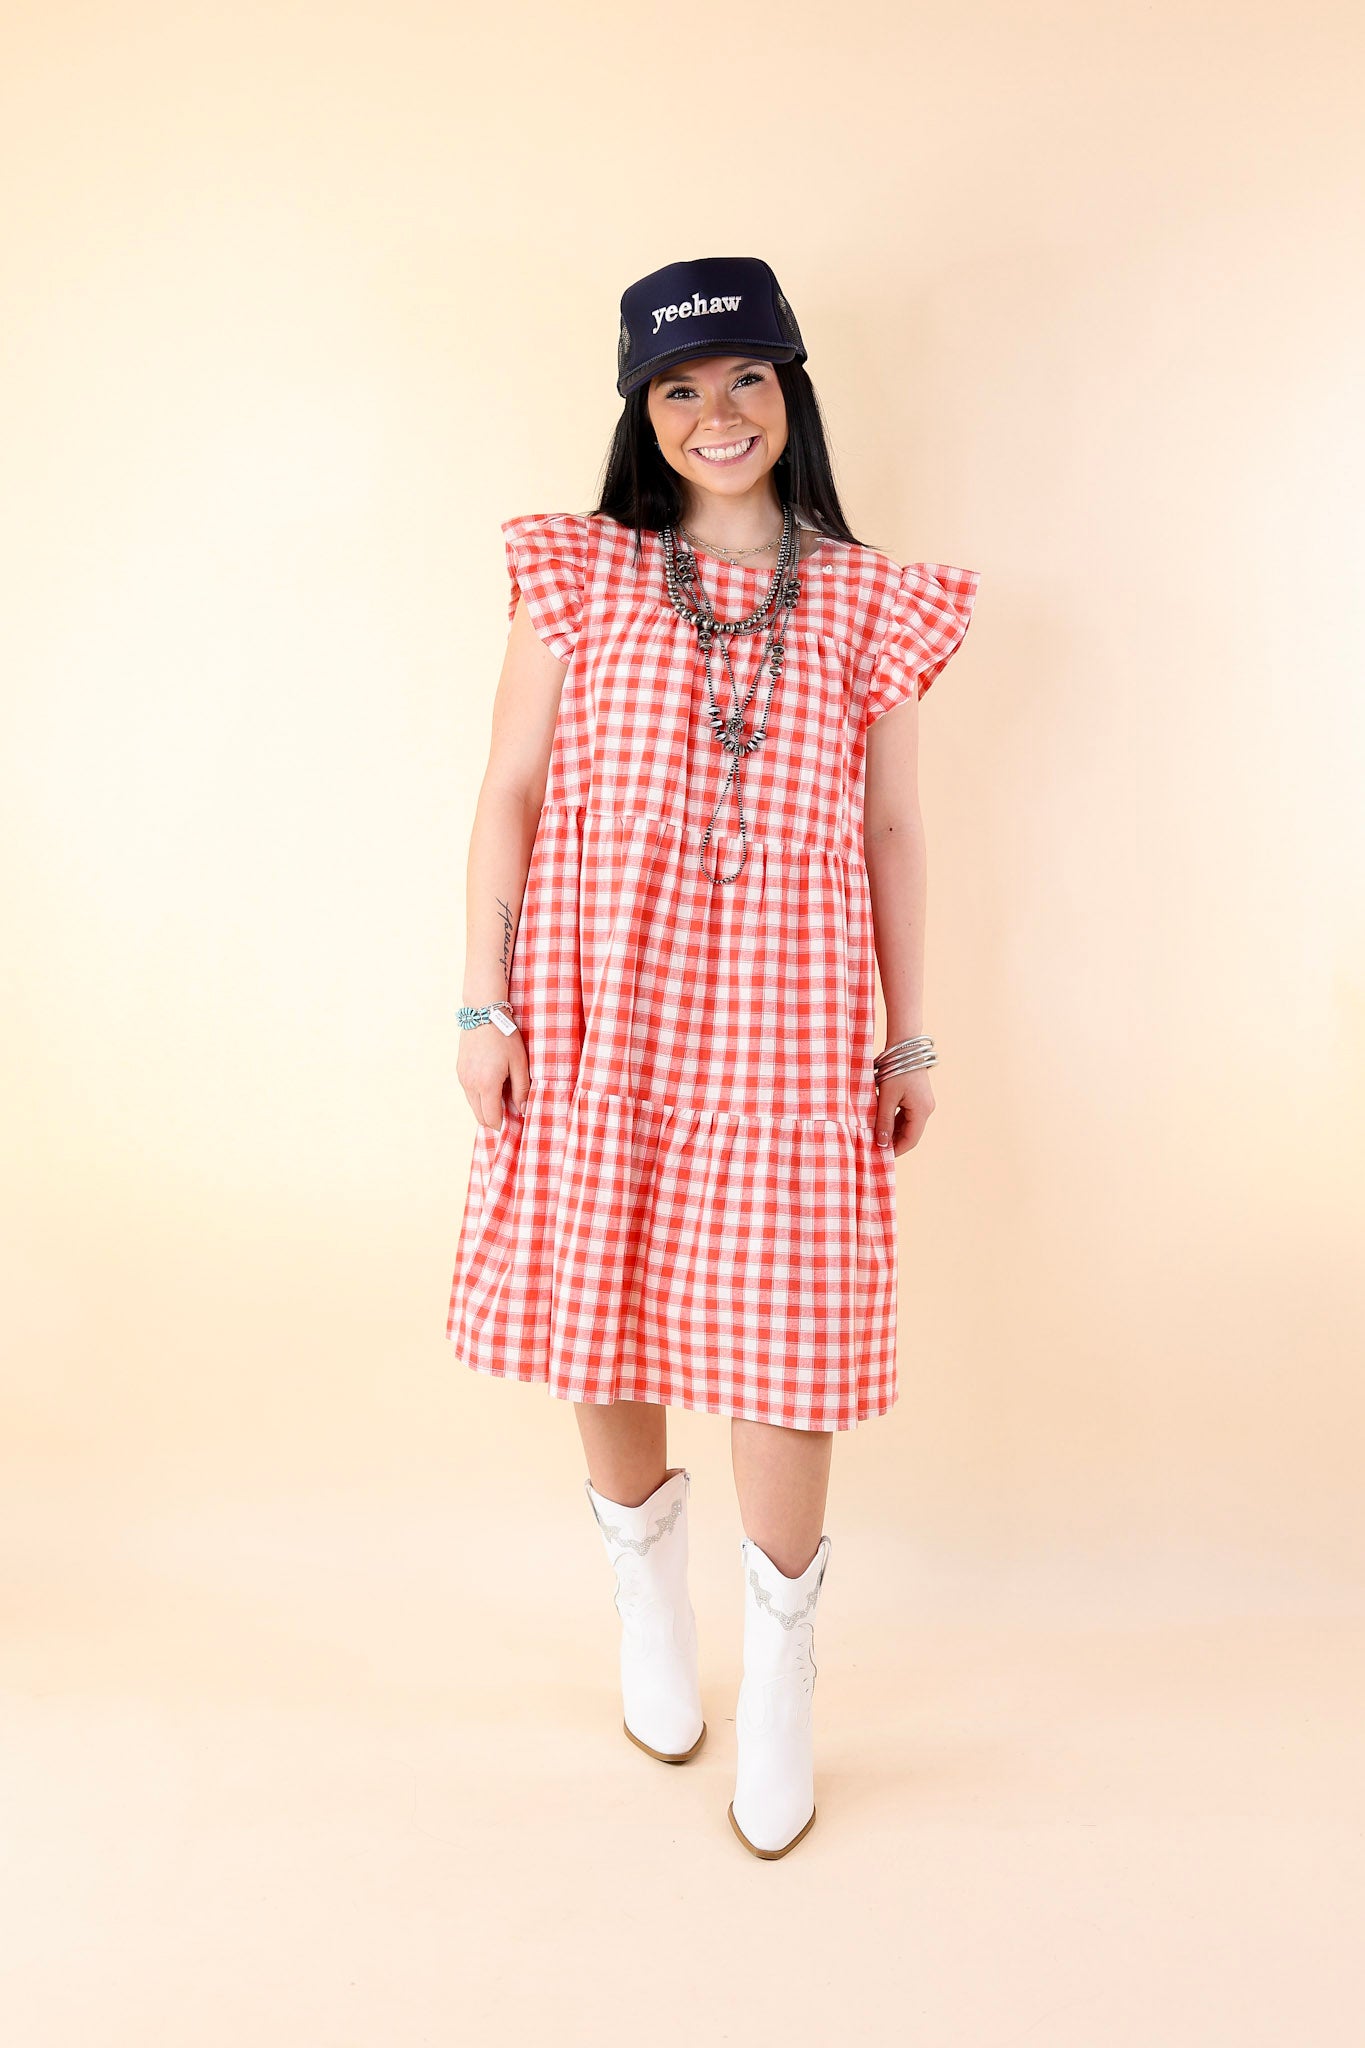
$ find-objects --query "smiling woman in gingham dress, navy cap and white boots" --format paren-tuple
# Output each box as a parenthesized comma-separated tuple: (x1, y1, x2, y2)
(446, 258, 976, 1858)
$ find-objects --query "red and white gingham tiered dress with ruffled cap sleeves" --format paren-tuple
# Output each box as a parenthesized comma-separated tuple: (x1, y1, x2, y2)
(446, 512, 978, 1430)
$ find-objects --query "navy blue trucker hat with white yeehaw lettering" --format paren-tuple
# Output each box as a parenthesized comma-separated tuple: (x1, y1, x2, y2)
(616, 256, 806, 397)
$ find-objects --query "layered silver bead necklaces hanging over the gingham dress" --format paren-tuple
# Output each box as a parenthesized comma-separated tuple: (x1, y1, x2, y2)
(663, 504, 800, 883)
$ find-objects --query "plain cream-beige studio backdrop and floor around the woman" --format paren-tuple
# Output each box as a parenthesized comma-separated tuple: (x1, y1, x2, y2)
(0, 0, 1365, 2048)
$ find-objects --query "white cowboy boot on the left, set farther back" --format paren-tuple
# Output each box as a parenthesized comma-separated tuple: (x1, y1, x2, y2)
(583, 1470, 706, 1763)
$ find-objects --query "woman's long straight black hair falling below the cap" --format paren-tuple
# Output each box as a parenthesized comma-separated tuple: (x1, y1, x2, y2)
(593, 362, 866, 563)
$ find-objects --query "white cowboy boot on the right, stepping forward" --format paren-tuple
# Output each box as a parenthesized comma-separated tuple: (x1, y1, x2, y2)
(731, 1536, 831, 1860)
